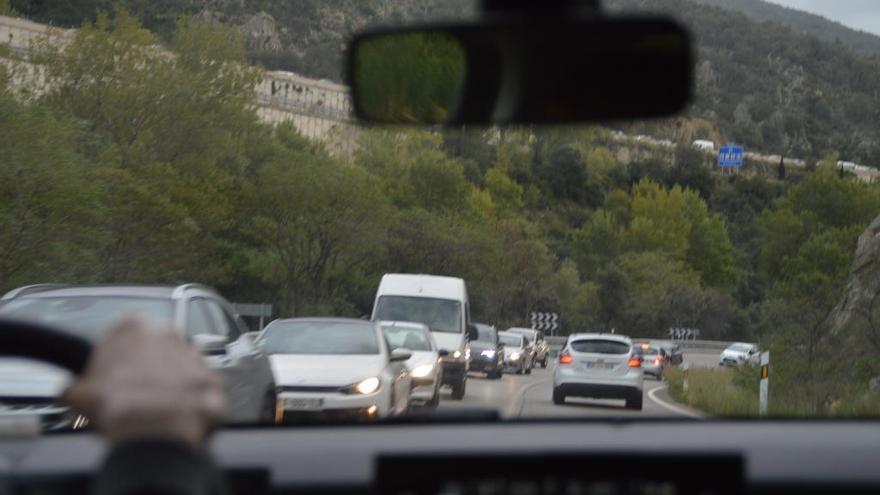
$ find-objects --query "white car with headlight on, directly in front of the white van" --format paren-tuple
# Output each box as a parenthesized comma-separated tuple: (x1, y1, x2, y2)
(381, 321, 447, 407)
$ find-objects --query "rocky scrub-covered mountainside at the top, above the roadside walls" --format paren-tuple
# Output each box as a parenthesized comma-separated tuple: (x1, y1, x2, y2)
(13, 0, 880, 166)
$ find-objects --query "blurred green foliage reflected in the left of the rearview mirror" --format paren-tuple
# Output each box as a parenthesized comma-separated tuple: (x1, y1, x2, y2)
(352, 31, 466, 124)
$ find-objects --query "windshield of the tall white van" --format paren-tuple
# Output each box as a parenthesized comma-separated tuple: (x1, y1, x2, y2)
(375, 296, 462, 333)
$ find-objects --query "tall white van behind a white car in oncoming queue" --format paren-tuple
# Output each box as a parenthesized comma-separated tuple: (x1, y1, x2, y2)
(372, 273, 478, 400)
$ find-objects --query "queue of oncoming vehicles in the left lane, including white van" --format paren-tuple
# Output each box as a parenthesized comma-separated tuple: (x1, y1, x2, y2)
(0, 274, 550, 430)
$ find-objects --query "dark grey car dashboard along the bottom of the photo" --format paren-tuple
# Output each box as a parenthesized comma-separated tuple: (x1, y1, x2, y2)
(0, 420, 880, 495)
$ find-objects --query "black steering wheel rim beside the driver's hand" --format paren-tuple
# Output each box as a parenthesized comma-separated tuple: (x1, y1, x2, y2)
(0, 317, 92, 375)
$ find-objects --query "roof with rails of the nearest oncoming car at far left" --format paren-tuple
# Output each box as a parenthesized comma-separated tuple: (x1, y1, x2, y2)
(3, 284, 207, 299)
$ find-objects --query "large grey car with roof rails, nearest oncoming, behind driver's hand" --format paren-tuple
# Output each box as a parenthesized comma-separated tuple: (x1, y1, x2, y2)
(0, 284, 276, 429)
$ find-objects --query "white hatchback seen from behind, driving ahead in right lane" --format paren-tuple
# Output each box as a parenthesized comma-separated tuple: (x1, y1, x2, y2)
(553, 333, 643, 411)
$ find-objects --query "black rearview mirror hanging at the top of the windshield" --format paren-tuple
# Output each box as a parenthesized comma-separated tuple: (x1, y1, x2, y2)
(348, 18, 693, 124)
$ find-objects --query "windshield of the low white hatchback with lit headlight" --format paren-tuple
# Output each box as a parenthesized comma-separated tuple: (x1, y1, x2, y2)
(258, 321, 379, 354)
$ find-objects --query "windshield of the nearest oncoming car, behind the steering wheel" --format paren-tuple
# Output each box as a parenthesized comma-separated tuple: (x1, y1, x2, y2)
(0, 296, 173, 340)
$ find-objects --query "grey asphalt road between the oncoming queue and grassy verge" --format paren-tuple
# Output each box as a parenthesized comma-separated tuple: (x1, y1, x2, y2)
(440, 353, 718, 419)
